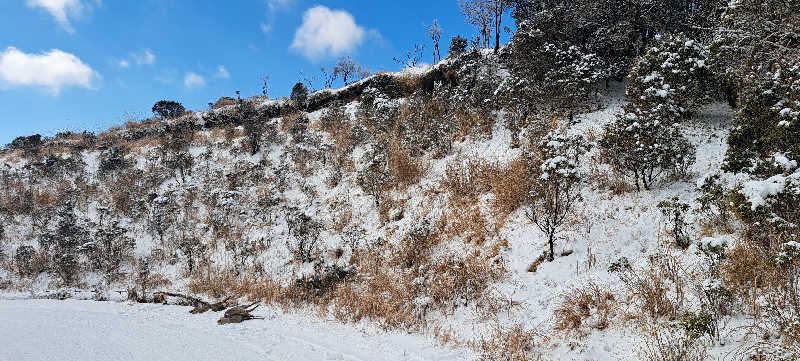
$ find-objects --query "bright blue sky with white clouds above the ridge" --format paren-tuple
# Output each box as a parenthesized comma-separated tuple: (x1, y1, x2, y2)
(0, 0, 512, 144)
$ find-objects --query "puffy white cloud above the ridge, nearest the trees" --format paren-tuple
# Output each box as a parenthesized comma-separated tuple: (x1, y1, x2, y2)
(291, 6, 367, 60)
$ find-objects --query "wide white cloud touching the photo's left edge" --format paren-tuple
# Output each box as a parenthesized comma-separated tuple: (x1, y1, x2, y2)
(0, 47, 99, 95)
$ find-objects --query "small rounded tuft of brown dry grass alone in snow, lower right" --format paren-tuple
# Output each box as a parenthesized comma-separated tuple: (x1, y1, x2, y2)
(554, 282, 617, 335)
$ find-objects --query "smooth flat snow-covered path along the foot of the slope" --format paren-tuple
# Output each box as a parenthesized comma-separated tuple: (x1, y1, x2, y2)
(0, 300, 469, 361)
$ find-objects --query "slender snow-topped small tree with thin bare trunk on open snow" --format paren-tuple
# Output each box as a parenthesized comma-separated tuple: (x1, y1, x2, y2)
(525, 132, 586, 261)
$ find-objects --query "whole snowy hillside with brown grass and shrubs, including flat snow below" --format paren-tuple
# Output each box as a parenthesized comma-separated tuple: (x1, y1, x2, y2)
(0, 8, 800, 361)
